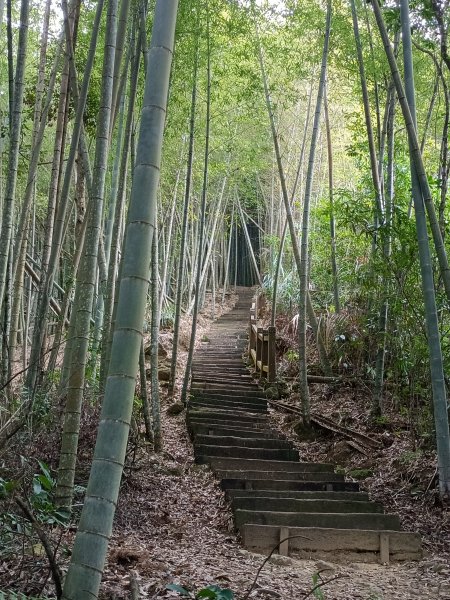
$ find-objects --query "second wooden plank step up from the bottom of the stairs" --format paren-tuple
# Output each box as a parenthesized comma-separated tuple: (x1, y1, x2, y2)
(234, 509, 401, 531)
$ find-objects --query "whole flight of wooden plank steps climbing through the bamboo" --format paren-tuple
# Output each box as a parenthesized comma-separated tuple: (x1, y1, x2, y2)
(187, 288, 422, 563)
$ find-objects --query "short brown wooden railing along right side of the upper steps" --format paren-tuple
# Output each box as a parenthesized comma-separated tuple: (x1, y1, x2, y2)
(248, 298, 277, 381)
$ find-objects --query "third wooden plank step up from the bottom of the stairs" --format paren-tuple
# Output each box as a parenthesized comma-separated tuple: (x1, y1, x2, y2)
(232, 496, 383, 513)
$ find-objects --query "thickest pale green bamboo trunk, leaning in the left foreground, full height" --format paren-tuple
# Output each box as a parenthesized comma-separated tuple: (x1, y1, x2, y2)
(63, 0, 178, 600)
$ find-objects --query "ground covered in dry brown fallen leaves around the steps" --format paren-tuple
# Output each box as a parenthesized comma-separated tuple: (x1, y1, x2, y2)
(0, 290, 450, 600)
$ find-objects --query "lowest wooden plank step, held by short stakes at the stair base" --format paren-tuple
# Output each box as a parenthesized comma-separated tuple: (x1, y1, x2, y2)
(241, 524, 422, 564)
